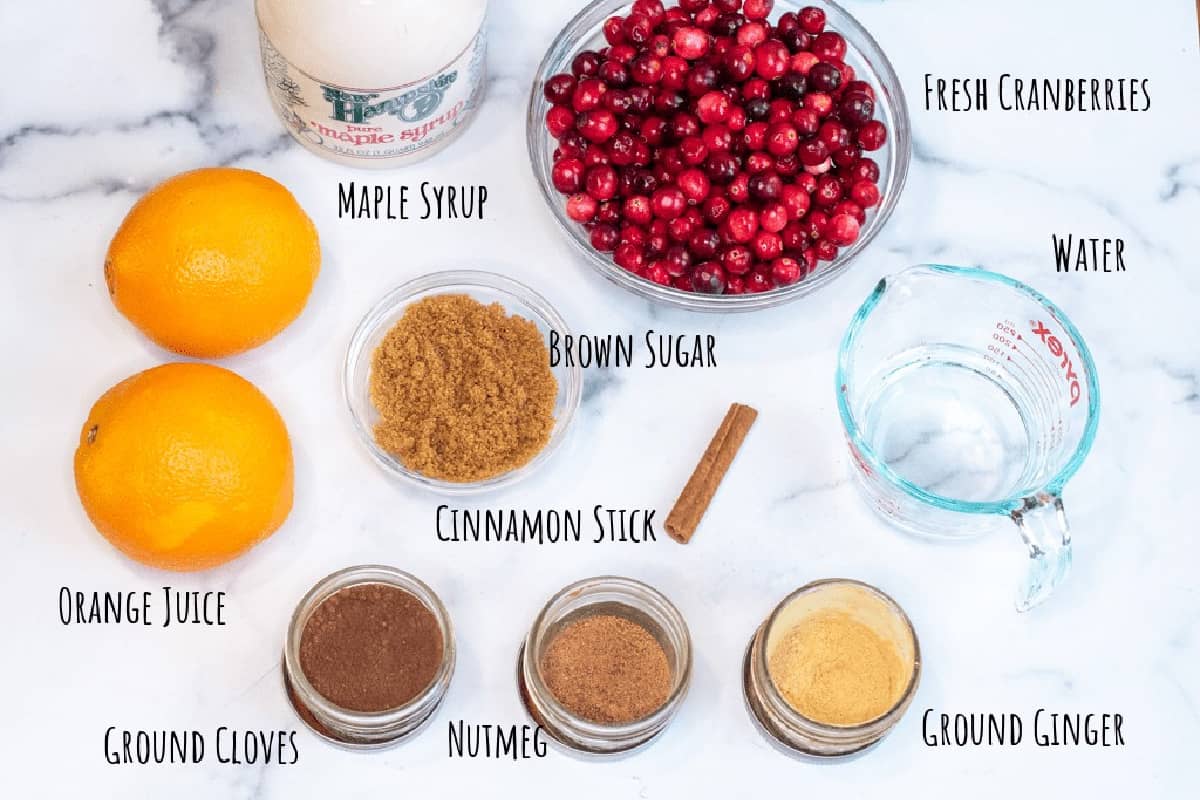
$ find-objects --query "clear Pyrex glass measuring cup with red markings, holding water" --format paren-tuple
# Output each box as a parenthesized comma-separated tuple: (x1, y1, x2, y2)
(838, 265, 1100, 610)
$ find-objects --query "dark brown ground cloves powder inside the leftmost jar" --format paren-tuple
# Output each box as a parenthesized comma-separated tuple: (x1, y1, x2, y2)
(300, 583, 443, 711)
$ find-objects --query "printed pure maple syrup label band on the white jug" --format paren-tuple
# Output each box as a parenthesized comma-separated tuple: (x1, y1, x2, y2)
(258, 26, 487, 161)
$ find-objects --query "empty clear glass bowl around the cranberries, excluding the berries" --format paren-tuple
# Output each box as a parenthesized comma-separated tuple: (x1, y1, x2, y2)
(526, 0, 912, 312)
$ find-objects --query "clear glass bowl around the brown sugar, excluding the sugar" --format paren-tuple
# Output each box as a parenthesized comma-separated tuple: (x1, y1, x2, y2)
(343, 270, 583, 495)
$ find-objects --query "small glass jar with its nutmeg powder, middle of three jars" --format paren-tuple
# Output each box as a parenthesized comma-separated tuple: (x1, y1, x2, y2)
(517, 577, 691, 756)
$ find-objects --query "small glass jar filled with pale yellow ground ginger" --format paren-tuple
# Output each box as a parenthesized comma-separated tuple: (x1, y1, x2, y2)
(743, 579, 920, 758)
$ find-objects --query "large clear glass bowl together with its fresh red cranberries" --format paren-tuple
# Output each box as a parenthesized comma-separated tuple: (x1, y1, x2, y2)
(528, 0, 912, 311)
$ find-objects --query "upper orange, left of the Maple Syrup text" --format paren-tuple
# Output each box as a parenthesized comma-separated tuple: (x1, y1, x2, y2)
(104, 167, 320, 359)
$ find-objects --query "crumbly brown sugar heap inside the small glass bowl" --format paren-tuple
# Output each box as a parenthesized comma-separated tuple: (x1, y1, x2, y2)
(371, 295, 558, 483)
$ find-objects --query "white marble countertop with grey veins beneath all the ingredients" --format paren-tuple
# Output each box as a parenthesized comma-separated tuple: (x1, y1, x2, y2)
(0, 0, 1200, 799)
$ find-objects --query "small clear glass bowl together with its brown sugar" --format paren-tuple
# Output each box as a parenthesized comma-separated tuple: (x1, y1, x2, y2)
(343, 270, 583, 495)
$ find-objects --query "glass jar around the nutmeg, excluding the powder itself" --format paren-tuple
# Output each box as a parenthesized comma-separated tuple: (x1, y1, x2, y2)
(517, 576, 691, 757)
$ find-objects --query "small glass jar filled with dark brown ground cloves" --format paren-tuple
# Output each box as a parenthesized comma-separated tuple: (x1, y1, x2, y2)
(283, 566, 455, 750)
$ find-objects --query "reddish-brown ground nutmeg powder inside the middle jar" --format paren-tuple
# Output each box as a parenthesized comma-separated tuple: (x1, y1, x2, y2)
(541, 614, 671, 724)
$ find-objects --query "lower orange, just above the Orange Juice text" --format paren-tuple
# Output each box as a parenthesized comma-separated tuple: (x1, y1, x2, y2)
(74, 363, 293, 571)
